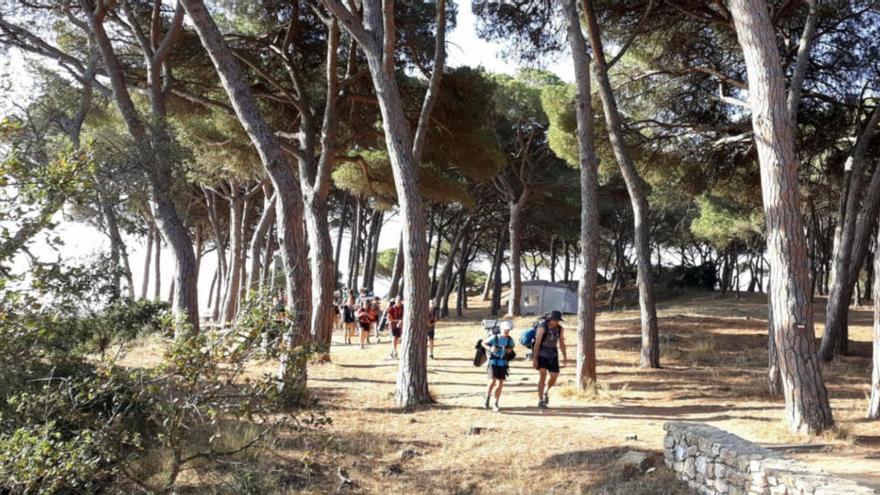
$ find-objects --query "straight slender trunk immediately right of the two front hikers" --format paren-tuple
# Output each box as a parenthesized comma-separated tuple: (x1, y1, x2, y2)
(564, 0, 599, 391)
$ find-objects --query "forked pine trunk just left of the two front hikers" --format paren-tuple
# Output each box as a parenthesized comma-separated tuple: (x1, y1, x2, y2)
(322, 0, 446, 408)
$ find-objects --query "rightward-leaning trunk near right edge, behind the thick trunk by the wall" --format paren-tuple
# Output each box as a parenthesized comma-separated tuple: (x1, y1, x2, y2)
(819, 105, 880, 361)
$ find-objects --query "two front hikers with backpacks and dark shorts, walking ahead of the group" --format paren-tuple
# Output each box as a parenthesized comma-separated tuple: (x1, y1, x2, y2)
(483, 311, 568, 412)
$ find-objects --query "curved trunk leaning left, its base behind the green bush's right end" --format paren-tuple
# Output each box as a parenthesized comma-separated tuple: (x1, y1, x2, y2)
(181, 0, 311, 401)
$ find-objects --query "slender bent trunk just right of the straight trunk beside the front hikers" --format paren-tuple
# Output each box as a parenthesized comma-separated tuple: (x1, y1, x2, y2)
(581, 0, 660, 368)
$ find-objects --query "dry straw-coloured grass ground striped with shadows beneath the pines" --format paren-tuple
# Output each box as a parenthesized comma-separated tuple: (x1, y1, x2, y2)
(118, 294, 880, 494)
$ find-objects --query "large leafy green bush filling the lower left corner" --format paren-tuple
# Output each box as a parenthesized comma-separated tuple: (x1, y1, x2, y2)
(0, 270, 316, 493)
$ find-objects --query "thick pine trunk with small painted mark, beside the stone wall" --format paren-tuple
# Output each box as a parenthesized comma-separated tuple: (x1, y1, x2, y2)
(730, 0, 834, 433)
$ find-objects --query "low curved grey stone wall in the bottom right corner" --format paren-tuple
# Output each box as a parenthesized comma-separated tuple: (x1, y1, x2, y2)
(663, 423, 876, 495)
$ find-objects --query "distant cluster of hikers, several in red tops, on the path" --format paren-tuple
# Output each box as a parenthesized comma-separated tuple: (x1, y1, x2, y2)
(336, 288, 439, 359)
